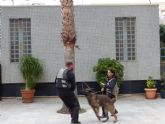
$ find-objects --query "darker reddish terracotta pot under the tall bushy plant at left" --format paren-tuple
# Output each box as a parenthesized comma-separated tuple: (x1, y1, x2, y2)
(21, 89, 35, 103)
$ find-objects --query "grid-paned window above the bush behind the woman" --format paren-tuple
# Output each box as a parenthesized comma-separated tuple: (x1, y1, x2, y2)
(115, 17, 136, 61)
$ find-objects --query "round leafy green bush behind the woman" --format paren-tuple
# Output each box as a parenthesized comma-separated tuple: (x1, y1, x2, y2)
(93, 58, 124, 98)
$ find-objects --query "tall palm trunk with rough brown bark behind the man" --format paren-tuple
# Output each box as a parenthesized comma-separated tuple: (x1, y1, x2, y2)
(58, 0, 76, 113)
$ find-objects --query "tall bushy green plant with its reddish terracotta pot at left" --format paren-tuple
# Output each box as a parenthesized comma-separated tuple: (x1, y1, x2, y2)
(19, 55, 43, 103)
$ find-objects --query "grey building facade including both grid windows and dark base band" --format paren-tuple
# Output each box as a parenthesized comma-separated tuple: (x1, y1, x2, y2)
(1, 5, 160, 96)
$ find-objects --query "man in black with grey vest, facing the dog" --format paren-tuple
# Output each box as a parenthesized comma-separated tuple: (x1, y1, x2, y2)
(55, 62, 81, 124)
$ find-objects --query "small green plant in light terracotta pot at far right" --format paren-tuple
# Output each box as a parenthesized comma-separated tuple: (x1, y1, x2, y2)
(144, 76, 157, 99)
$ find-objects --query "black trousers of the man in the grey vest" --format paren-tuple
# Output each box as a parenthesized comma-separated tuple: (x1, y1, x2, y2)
(58, 88, 80, 123)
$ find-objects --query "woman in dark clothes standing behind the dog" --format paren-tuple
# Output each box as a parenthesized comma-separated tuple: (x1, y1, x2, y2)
(102, 68, 118, 117)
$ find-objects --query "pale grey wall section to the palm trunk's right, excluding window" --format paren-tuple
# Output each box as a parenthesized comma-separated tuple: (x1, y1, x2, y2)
(76, 6, 160, 81)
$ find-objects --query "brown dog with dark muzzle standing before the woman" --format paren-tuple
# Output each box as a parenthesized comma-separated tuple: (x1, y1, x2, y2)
(85, 89, 117, 123)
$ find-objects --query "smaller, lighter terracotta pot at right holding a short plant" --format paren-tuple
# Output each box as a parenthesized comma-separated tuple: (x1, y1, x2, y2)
(144, 88, 157, 99)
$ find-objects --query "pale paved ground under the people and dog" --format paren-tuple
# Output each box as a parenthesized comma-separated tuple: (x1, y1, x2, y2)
(0, 94, 165, 124)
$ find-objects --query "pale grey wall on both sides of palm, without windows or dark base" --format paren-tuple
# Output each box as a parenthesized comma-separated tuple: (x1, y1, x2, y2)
(2, 5, 160, 83)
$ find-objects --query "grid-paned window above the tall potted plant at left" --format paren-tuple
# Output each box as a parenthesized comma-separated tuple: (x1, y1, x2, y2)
(9, 18, 31, 62)
